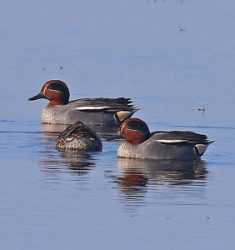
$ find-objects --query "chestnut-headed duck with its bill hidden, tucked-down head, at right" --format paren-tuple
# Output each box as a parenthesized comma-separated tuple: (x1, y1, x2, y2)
(117, 118, 213, 161)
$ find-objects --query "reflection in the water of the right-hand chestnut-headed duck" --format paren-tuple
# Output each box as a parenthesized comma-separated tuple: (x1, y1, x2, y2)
(118, 158, 207, 199)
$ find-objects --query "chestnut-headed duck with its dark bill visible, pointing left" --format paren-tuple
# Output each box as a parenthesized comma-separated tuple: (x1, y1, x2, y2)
(28, 80, 138, 126)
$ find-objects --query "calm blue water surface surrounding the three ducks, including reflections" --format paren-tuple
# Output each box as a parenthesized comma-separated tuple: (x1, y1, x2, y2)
(0, 0, 235, 250)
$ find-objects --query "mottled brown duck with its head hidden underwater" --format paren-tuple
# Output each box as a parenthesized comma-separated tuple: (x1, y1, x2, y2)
(56, 121, 102, 151)
